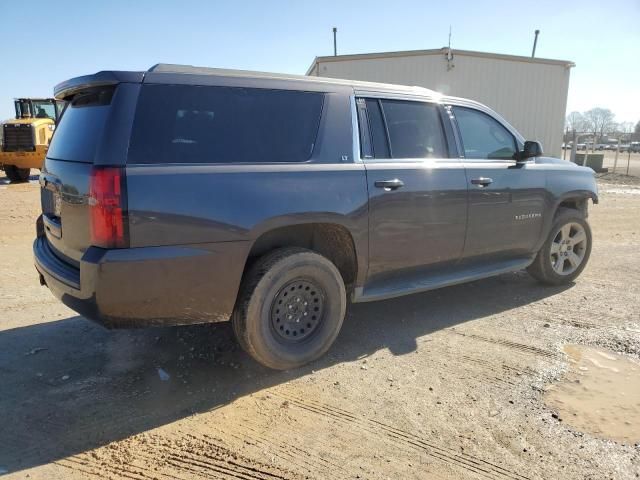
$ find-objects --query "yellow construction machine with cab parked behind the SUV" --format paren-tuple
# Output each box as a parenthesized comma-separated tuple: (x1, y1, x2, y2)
(0, 98, 64, 183)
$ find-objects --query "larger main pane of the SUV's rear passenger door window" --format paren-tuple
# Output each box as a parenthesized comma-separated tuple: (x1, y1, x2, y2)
(381, 100, 447, 158)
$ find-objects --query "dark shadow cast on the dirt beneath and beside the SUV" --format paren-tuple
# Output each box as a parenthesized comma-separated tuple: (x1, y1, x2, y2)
(0, 273, 566, 472)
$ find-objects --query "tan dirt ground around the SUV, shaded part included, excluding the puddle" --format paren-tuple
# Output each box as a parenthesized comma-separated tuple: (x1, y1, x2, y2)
(0, 171, 640, 480)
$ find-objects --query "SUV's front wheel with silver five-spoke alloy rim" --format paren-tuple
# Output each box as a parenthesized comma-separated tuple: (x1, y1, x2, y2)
(527, 208, 592, 285)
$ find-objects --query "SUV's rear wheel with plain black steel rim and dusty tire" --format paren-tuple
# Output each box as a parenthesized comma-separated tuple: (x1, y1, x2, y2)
(231, 248, 347, 370)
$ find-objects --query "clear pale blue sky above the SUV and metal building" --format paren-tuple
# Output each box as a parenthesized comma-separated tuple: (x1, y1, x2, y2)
(0, 0, 640, 123)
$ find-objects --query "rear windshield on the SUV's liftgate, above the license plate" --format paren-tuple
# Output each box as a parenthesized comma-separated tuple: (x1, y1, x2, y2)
(47, 88, 114, 163)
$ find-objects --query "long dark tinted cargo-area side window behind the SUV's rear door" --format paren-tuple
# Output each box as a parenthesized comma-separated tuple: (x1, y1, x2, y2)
(128, 85, 324, 164)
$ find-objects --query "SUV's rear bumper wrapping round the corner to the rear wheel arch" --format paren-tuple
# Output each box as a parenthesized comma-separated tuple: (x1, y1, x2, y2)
(33, 236, 247, 328)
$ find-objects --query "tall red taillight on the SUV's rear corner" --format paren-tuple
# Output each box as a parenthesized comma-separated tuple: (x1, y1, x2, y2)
(89, 167, 128, 248)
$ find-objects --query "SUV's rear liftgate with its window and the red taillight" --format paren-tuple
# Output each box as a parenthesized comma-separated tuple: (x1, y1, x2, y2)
(40, 85, 131, 267)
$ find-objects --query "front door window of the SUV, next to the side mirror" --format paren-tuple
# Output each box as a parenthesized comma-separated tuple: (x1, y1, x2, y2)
(453, 107, 516, 159)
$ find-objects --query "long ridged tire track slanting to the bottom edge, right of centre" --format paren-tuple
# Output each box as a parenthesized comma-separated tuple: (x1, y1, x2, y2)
(274, 392, 529, 480)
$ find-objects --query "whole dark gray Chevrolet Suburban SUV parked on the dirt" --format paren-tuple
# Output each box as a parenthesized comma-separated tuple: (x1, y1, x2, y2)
(33, 65, 597, 369)
